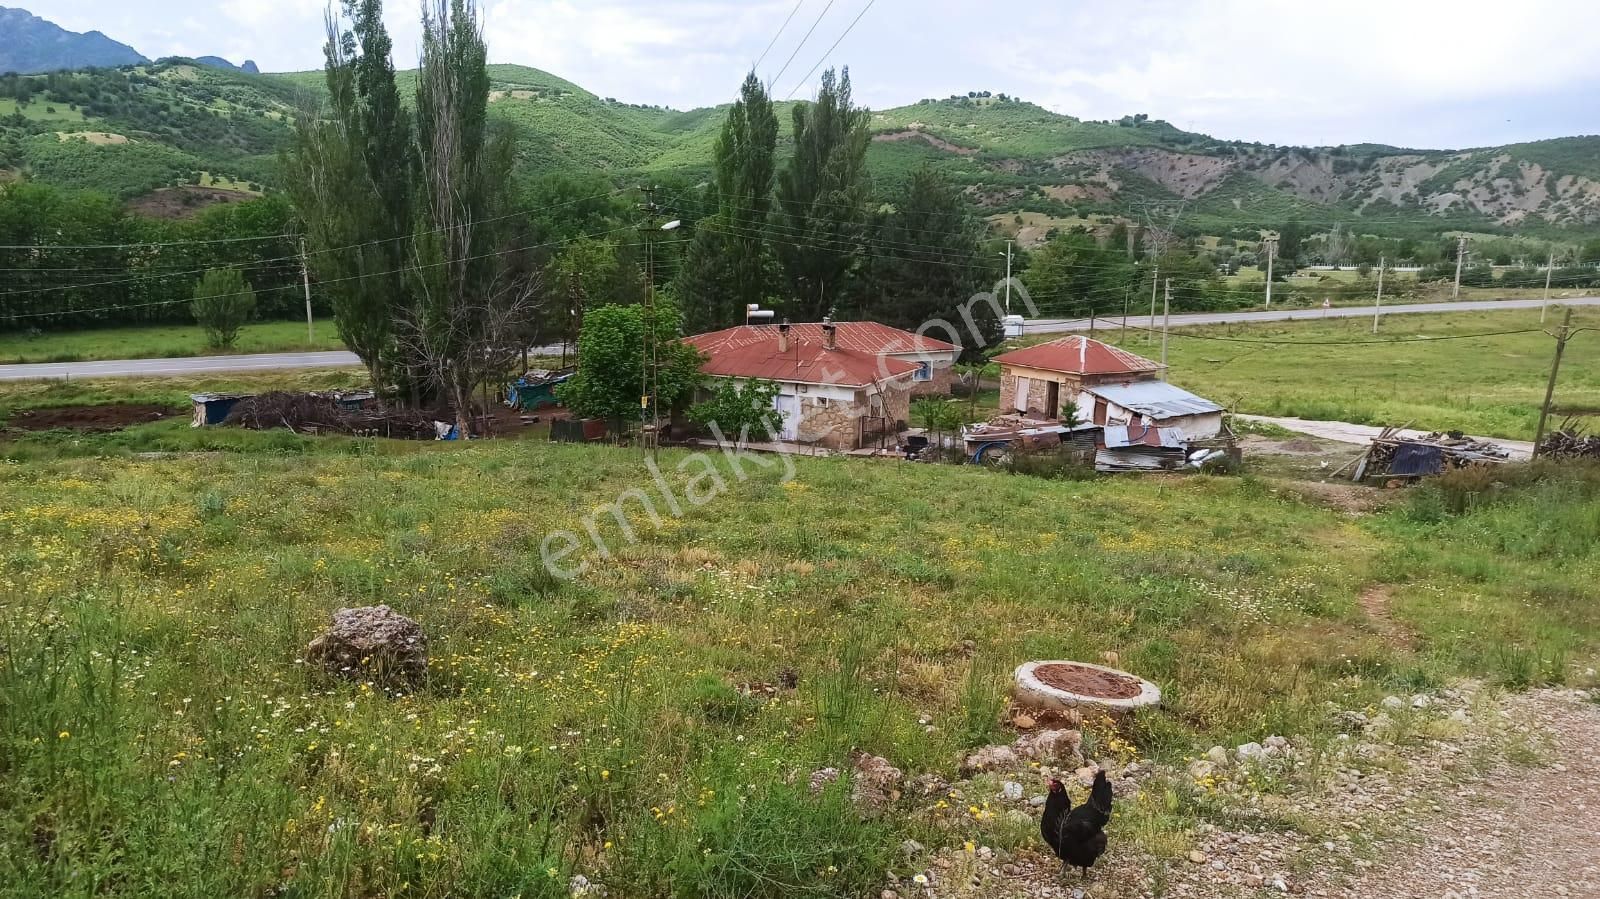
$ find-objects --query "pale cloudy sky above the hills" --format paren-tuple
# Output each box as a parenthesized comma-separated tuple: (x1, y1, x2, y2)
(21, 0, 1600, 147)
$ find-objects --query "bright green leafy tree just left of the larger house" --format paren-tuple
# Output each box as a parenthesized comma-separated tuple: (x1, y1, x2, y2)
(557, 296, 702, 426)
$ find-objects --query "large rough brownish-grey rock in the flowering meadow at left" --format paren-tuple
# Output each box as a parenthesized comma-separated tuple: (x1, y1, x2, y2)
(306, 606, 427, 686)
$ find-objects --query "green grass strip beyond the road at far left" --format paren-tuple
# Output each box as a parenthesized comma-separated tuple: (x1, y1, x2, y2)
(0, 320, 344, 365)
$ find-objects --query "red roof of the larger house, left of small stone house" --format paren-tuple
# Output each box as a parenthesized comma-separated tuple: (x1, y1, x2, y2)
(683, 325, 938, 387)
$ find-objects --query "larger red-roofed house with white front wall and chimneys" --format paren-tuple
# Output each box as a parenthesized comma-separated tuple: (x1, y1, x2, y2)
(685, 320, 960, 450)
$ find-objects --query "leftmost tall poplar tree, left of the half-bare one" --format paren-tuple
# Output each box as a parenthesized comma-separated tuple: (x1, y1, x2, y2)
(283, 0, 416, 389)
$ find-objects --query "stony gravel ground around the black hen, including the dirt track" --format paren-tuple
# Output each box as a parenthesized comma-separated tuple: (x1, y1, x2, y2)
(885, 686, 1600, 899)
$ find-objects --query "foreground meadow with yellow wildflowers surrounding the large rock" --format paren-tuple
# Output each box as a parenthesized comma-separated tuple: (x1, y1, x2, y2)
(0, 412, 1600, 897)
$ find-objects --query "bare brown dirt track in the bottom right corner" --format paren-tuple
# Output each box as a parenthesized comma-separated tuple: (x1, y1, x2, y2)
(1346, 693, 1600, 899)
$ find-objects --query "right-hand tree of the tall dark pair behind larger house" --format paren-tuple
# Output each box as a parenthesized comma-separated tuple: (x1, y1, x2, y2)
(774, 69, 867, 320)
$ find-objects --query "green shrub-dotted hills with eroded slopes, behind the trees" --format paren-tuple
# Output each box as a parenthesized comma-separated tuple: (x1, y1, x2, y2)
(0, 59, 1600, 237)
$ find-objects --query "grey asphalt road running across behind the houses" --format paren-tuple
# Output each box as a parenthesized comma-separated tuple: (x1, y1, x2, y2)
(0, 296, 1600, 381)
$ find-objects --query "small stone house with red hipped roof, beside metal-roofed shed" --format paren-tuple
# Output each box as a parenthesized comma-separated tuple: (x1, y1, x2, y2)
(994, 334, 1165, 424)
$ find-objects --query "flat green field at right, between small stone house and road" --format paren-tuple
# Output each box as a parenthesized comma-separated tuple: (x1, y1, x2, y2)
(1068, 309, 1600, 440)
